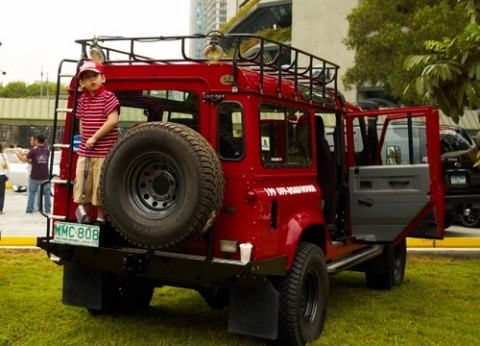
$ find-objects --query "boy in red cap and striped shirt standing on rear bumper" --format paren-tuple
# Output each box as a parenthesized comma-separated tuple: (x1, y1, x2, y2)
(73, 60, 120, 225)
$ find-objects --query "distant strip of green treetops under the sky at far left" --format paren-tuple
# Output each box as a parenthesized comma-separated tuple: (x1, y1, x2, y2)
(0, 81, 67, 98)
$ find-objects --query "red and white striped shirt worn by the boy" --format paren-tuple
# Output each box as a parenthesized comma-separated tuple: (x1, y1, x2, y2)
(76, 85, 120, 157)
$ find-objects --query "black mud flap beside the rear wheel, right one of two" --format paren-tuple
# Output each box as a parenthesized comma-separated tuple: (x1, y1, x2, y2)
(228, 281, 280, 340)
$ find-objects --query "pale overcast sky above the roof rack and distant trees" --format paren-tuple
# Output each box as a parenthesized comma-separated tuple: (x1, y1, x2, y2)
(0, 0, 190, 86)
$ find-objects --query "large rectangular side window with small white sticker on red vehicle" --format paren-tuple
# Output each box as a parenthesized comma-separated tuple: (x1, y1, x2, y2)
(260, 103, 312, 167)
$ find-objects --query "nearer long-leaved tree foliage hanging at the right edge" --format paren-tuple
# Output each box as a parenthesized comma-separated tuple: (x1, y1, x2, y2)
(405, 0, 480, 123)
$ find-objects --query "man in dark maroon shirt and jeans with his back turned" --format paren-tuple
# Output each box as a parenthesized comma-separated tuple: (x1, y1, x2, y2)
(16, 135, 52, 214)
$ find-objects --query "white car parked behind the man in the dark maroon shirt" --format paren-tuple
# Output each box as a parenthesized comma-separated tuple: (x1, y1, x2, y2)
(3, 148, 60, 192)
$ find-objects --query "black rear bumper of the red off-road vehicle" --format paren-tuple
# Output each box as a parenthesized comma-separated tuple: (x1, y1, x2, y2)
(37, 237, 287, 286)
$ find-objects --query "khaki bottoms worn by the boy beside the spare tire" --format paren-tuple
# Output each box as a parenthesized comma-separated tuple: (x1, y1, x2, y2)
(73, 156, 105, 206)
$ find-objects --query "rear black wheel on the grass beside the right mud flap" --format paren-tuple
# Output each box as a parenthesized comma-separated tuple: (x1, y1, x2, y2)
(274, 243, 328, 345)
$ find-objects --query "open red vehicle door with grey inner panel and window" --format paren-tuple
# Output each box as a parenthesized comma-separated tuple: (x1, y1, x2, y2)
(346, 107, 445, 242)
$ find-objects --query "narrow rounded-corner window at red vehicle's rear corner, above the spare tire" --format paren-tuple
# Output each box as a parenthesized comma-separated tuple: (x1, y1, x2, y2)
(217, 102, 245, 160)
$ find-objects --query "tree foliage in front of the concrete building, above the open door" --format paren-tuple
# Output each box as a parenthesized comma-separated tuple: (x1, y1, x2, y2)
(343, 0, 468, 104)
